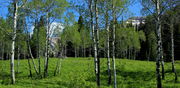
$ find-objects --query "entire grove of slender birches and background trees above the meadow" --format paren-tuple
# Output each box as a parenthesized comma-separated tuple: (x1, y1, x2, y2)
(0, 0, 180, 88)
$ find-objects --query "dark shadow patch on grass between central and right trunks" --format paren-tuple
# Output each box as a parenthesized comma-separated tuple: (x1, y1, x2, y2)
(97, 69, 156, 88)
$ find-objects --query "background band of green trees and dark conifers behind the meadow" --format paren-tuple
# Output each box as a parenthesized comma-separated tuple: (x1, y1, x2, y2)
(0, 1, 180, 61)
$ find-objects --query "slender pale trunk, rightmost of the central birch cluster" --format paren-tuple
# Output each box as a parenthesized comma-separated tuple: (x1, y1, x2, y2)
(112, 0, 117, 88)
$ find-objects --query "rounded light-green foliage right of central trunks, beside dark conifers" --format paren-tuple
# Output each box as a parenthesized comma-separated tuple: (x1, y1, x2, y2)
(116, 28, 146, 51)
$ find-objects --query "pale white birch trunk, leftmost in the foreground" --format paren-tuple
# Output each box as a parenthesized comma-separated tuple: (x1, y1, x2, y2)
(10, 0, 18, 84)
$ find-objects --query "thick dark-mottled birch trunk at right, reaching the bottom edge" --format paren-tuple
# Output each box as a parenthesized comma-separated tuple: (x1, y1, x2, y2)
(156, 0, 162, 88)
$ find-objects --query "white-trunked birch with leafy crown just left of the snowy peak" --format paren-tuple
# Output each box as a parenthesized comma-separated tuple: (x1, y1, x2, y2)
(43, 0, 68, 77)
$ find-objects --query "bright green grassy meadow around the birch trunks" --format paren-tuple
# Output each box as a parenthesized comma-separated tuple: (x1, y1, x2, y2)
(0, 58, 180, 88)
